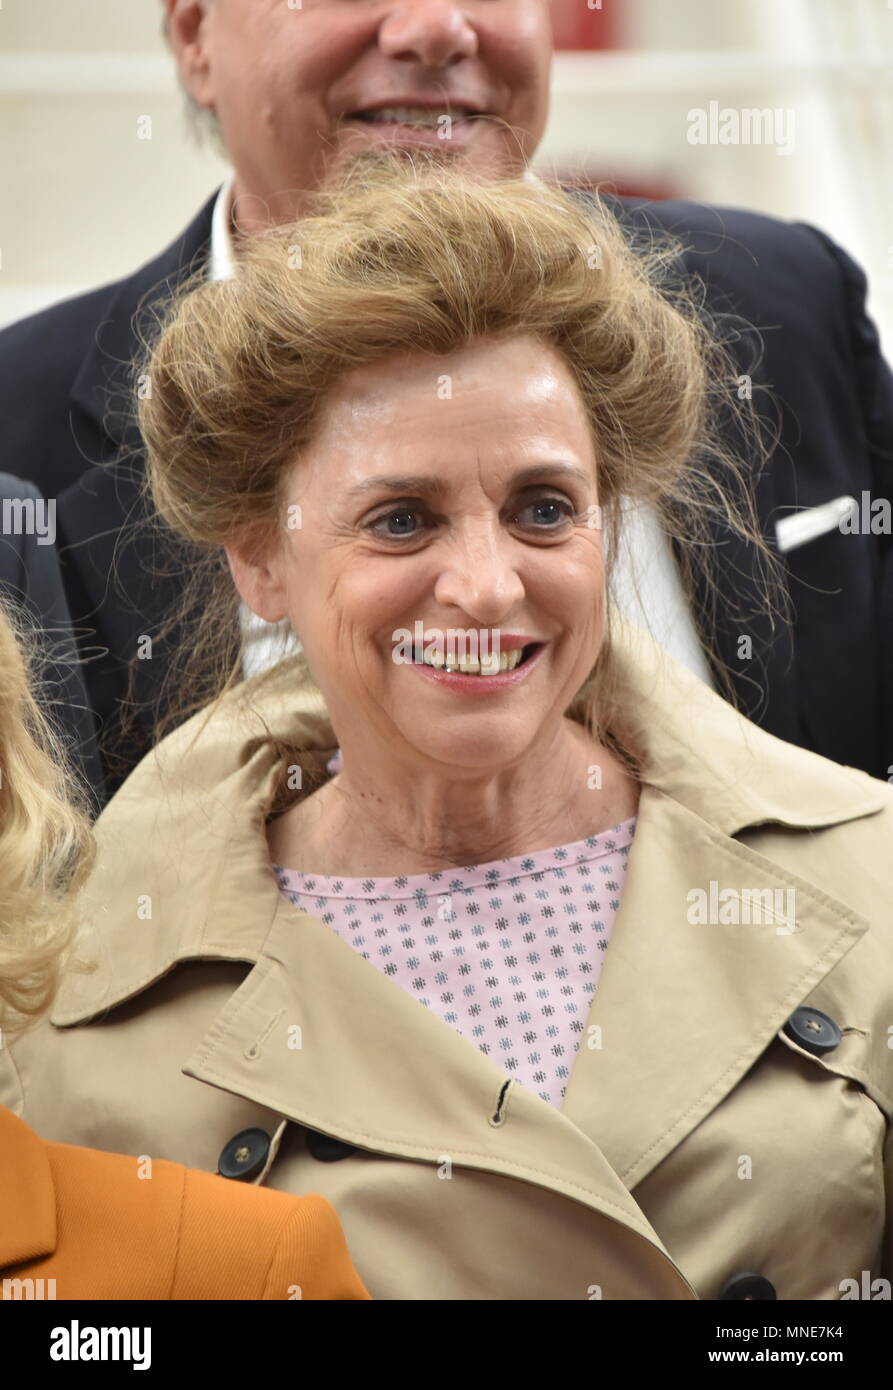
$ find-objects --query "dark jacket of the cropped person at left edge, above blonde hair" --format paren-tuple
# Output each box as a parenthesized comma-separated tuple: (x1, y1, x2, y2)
(0, 473, 103, 795)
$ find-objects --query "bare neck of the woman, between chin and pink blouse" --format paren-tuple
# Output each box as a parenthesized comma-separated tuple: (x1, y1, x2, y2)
(267, 720, 638, 878)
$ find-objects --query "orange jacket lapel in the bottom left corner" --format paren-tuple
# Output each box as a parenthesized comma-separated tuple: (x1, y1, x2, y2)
(0, 1105, 56, 1270)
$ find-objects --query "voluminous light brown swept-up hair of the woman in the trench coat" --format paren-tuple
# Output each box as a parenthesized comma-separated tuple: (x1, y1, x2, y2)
(126, 154, 775, 783)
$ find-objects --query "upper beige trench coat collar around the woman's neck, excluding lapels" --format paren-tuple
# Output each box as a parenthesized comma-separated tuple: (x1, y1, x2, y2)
(50, 613, 889, 1026)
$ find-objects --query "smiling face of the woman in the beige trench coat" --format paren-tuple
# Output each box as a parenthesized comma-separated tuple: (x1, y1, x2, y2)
(228, 336, 604, 773)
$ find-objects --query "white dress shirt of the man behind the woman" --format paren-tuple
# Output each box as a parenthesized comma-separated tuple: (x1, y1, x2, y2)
(207, 171, 714, 685)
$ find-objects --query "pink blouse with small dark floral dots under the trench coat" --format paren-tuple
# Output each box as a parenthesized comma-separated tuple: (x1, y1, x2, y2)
(274, 817, 636, 1106)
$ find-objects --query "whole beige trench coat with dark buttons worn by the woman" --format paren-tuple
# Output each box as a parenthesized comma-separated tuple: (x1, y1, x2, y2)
(0, 630, 893, 1300)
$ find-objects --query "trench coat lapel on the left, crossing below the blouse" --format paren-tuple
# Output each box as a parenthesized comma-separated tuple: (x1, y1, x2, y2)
(184, 885, 692, 1278)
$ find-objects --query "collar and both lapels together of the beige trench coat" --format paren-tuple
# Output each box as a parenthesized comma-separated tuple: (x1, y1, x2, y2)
(51, 621, 890, 1200)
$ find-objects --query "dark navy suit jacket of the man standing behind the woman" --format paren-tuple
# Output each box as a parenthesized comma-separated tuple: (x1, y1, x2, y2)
(0, 195, 893, 811)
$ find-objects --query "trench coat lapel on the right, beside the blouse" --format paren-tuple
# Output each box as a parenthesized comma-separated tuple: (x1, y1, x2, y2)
(563, 788, 868, 1187)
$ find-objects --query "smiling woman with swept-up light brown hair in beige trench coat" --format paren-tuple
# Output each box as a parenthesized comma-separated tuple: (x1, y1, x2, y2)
(6, 160, 893, 1300)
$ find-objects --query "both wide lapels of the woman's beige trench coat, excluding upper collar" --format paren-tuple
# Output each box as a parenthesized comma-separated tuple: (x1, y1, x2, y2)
(184, 787, 868, 1238)
